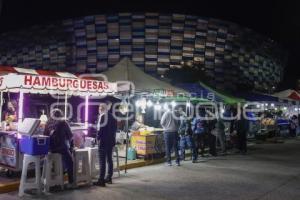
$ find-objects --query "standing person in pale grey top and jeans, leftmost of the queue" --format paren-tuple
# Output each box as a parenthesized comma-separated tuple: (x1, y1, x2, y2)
(160, 108, 180, 166)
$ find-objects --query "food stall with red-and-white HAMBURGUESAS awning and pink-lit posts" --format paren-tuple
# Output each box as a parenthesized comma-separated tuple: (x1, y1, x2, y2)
(0, 66, 117, 171)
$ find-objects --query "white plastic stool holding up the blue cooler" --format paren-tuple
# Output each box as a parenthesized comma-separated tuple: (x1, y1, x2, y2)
(19, 154, 41, 197)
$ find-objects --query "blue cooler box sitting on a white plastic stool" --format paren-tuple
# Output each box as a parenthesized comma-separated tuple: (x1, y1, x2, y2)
(20, 135, 50, 156)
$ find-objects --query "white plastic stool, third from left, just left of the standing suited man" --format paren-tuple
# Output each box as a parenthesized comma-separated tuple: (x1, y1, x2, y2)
(74, 149, 92, 186)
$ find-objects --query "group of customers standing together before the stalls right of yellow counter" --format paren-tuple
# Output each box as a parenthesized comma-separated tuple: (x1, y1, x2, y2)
(160, 107, 249, 166)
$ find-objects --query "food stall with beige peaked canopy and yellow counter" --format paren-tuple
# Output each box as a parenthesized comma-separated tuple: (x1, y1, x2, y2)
(103, 58, 187, 162)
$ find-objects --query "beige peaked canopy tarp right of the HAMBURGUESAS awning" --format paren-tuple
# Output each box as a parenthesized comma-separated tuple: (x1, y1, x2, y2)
(102, 58, 187, 94)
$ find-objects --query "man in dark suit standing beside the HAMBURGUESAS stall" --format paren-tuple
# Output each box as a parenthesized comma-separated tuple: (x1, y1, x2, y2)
(95, 101, 117, 187)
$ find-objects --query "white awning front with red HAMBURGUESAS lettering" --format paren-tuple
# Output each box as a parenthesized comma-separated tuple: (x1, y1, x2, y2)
(0, 74, 117, 93)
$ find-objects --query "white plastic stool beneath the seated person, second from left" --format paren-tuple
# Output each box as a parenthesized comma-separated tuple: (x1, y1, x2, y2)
(42, 153, 64, 192)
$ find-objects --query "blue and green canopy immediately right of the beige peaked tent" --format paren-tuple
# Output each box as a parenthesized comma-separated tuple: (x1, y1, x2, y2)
(176, 82, 245, 104)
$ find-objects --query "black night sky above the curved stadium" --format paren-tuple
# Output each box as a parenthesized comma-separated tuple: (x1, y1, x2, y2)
(0, 0, 300, 89)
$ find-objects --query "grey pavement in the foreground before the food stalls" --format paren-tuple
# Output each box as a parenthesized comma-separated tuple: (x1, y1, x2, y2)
(0, 140, 300, 200)
